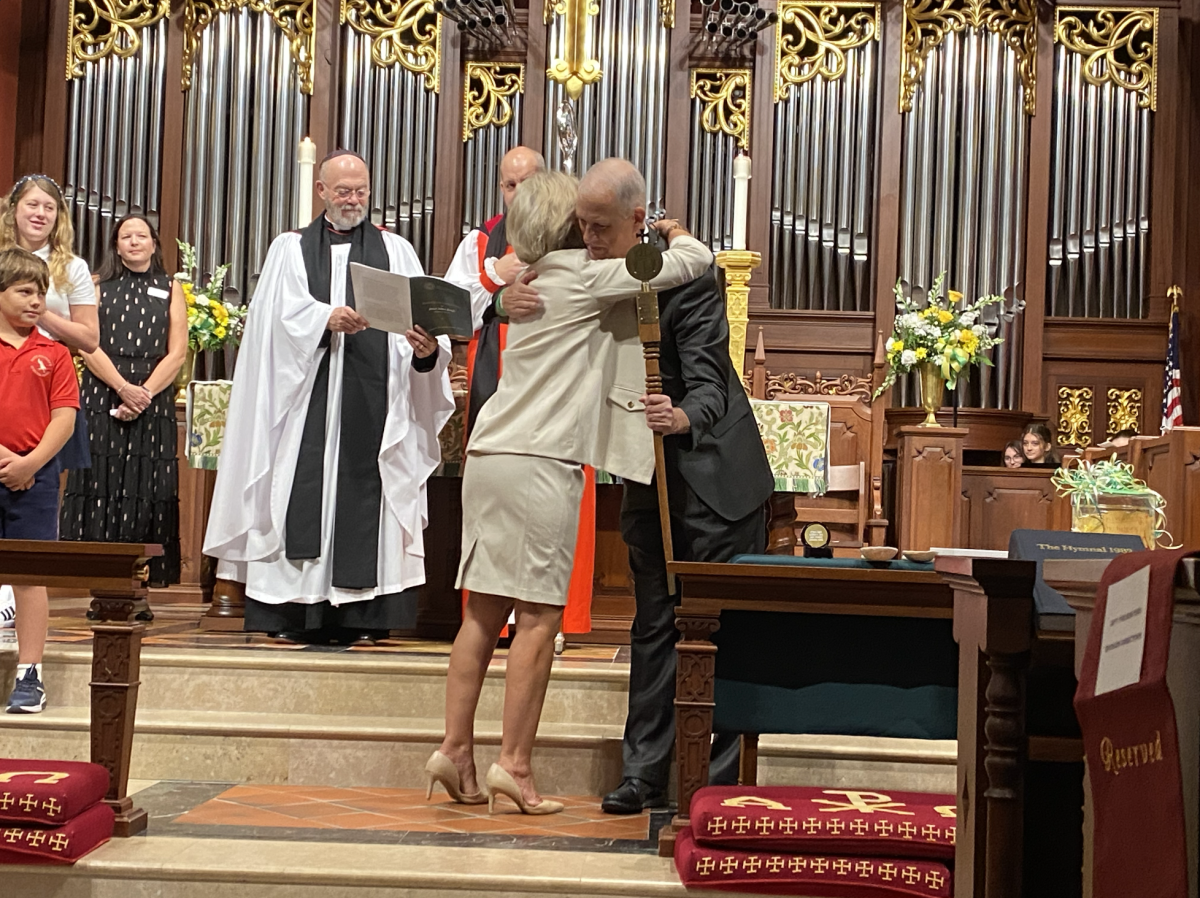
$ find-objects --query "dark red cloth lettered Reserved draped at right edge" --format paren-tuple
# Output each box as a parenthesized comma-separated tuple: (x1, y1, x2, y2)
(1075, 550, 1190, 898)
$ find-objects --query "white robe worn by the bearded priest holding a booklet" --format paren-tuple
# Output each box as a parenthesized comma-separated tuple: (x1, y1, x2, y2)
(204, 232, 455, 605)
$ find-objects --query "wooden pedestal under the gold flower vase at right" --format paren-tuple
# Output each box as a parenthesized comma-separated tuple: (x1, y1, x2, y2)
(896, 426, 967, 552)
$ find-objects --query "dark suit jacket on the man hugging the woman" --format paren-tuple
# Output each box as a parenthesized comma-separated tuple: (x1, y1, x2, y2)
(659, 268, 775, 521)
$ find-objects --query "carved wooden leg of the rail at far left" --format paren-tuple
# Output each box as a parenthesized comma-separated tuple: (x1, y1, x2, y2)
(91, 588, 146, 836)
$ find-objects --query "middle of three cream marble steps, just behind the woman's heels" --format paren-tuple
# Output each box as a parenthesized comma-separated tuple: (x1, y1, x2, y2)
(0, 706, 955, 796)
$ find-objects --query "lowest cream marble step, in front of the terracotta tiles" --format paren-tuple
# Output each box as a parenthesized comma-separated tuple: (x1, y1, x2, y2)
(4, 837, 763, 898)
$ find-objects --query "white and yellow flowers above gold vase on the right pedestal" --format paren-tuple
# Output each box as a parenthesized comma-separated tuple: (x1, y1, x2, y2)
(875, 271, 1003, 397)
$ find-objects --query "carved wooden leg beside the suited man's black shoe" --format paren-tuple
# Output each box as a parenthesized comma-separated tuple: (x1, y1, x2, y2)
(659, 607, 721, 857)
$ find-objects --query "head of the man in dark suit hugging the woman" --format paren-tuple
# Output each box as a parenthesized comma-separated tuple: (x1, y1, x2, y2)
(575, 158, 646, 259)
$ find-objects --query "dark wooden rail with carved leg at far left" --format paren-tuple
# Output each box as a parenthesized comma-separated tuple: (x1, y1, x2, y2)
(0, 539, 162, 836)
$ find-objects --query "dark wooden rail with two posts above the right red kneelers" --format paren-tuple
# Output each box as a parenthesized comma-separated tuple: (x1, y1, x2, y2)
(659, 558, 1036, 898)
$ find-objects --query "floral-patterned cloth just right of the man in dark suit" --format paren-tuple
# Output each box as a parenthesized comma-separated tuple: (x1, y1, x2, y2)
(750, 399, 829, 496)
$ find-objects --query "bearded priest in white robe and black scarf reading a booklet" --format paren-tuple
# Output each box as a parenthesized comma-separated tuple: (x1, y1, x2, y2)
(204, 151, 454, 642)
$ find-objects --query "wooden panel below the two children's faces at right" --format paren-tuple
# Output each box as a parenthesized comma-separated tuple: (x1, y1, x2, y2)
(961, 467, 1070, 550)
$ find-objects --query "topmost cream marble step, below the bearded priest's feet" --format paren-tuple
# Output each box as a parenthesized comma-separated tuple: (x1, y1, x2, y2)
(25, 645, 629, 726)
